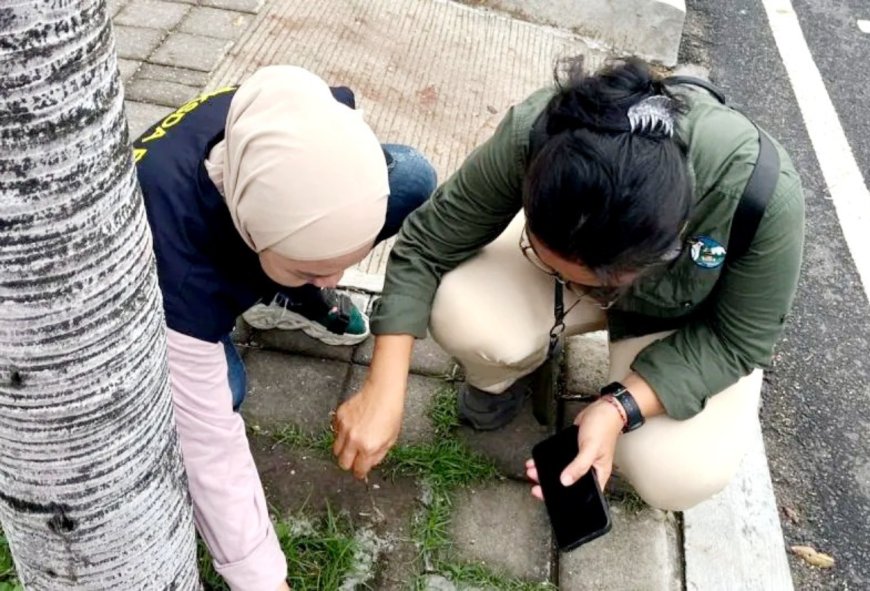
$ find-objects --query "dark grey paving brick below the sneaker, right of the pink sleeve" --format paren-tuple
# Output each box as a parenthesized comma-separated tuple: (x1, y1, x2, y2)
(242, 350, 349, 434)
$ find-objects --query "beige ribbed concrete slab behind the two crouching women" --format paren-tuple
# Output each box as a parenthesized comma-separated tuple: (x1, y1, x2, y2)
(209, 0, 604, 288)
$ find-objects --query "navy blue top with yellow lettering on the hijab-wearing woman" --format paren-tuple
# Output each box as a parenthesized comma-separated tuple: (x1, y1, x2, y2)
(133, 88, 354, 342)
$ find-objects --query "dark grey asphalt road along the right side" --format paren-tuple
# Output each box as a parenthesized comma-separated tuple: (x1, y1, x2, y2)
(683, 0, 870, 590)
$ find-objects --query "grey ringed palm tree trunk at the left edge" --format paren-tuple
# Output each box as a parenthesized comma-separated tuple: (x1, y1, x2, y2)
(0, 0, 199, 590)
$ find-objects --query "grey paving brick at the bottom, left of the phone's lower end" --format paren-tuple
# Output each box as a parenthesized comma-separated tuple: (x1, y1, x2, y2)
(451, 480, 552, 589)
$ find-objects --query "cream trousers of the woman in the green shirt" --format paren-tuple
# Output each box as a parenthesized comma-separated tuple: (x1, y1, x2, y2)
(430, 214, 762, 511)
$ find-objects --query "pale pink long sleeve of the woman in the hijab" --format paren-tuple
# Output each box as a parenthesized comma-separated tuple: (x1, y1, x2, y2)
(166, 329, 287, 591)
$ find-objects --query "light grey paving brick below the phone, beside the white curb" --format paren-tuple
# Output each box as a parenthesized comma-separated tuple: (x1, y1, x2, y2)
(559, 504, 682, 591)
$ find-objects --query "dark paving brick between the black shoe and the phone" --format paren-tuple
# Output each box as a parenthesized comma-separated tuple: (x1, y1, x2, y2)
(459, 402, 551, 480)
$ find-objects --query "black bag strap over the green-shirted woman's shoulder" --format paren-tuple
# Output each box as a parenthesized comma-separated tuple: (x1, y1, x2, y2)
(663, 76, 779, 262)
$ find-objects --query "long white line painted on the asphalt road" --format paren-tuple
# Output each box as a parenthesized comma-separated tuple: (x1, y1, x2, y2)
(762, 0, 870, 300)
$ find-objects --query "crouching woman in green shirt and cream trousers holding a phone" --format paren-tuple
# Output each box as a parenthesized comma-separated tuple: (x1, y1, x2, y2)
(334, 60, 804, 510)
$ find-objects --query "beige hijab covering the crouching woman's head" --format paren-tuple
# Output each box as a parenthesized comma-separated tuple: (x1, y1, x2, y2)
(205, 66, 389, 261)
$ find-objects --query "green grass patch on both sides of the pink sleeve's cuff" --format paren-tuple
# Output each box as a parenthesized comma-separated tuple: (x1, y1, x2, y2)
(198, 510, 365, 591)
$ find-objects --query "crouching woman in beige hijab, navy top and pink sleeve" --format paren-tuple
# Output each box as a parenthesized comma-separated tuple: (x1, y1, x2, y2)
(134, 66, 435, 591)
